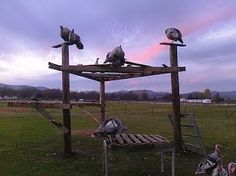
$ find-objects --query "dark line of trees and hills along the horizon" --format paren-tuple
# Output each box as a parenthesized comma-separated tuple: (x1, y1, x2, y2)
(0, 87, 227, 102)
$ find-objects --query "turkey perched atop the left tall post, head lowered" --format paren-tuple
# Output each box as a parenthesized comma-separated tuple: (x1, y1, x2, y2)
(60, 26, 84, 49)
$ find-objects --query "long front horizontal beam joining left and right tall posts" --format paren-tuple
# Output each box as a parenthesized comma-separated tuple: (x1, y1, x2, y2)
(48, 62, 185, 74)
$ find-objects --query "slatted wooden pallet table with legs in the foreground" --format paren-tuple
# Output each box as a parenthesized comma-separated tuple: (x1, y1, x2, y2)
(103, 134, 175, 176)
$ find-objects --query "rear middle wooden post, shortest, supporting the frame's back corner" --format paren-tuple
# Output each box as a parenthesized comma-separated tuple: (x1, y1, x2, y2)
(99, 79, 106, 124)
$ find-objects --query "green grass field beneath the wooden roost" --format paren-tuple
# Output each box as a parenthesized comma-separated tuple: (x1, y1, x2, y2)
(0, 103, 236, 176)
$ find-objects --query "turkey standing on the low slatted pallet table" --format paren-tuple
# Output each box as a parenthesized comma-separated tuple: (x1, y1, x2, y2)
(92, 118, 127, 139)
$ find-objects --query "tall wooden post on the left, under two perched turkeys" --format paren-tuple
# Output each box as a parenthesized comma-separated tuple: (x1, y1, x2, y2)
(62, 43, 72, 155)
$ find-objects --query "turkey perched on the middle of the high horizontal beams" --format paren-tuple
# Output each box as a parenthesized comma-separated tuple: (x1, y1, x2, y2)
(104, 46, 125, 66)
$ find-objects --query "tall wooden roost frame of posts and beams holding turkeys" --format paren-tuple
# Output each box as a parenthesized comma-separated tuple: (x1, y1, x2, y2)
(5, 42, 185, 155)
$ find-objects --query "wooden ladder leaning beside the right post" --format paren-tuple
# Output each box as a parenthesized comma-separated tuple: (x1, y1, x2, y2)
(169, 113, 206, 155)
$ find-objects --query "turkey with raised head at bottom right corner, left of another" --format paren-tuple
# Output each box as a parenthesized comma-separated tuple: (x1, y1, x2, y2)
(195, 144, 222, 175)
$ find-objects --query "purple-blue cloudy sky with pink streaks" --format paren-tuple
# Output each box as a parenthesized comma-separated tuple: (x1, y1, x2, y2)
(0, 0, 236, 93)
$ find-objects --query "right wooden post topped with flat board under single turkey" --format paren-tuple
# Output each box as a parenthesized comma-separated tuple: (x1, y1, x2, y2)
(161, 43, 186, 152)
